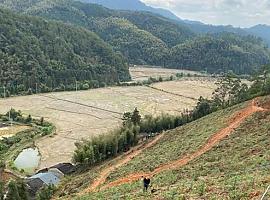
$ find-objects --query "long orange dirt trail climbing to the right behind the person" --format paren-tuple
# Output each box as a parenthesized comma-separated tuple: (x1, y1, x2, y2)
(100, 99, 265, 190)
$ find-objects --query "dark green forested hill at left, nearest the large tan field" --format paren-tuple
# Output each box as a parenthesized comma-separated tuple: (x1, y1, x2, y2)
(0, 9, 130, 93)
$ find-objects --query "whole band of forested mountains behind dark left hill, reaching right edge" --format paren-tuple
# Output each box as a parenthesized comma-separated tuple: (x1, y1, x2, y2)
(2, 0, 270, 73)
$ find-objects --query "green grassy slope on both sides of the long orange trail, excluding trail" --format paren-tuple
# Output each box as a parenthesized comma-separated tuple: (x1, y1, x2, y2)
(72, 97, 270, 199)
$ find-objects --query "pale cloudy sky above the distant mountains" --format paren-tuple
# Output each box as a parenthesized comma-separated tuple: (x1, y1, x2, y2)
(141, 0, 270, 27)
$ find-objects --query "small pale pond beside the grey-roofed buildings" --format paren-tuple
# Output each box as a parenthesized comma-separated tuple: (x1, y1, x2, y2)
(14, 148, 40, 173)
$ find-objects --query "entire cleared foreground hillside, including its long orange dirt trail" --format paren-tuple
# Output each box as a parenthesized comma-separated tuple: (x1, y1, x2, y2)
(54, 97, 270, 199)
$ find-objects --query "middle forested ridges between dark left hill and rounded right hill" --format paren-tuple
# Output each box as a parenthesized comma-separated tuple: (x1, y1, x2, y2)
(24, 1, 192, 65)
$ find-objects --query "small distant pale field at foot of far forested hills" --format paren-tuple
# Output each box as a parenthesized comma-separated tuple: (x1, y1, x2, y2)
(129, 65, 202, 81)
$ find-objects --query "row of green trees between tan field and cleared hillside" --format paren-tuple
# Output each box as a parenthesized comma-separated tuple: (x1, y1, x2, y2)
(73, 100, 215, 166)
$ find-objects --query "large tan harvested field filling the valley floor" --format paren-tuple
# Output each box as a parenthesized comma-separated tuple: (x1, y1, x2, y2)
(0, 78, 215, 168)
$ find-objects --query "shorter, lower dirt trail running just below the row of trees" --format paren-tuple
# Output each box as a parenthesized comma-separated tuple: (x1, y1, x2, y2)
(82, 133, 164, 194)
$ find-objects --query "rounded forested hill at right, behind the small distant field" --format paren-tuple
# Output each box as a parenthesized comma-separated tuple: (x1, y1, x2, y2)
(168, 33, 270, 74)
